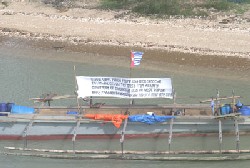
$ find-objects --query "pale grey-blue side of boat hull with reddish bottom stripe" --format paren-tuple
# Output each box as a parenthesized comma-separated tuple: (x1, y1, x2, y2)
(0, 115, 250, 140)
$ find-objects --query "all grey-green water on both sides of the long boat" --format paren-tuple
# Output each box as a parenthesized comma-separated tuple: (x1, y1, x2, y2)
(0, 42, 250, 168)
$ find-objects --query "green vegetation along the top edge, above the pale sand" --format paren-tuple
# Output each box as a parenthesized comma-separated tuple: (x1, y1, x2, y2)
(101, 0, 250, 17)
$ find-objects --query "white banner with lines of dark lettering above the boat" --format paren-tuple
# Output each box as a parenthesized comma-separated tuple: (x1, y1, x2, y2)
(76, 76, 173, 99)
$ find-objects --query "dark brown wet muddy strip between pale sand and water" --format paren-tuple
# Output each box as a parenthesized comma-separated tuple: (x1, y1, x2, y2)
(0, 36, 250, 71)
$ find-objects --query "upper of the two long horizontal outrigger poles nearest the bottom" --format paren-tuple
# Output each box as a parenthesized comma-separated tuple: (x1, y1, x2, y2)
(4, 147, 250, 155)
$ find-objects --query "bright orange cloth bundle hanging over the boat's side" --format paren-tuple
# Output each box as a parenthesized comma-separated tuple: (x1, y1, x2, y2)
(84, 114, 128, 128)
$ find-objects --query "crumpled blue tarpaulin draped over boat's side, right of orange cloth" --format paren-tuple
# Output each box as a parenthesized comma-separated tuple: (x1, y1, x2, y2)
(128, 114, 175, 124)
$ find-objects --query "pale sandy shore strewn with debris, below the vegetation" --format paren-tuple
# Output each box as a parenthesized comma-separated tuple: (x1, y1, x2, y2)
(0, 2, 250, 69)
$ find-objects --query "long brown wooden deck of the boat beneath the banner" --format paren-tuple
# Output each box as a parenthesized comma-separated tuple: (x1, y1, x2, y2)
(35, 104, 212, 116)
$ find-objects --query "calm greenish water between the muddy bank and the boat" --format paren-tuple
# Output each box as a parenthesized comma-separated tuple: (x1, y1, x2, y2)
(0, 46, 250, 105)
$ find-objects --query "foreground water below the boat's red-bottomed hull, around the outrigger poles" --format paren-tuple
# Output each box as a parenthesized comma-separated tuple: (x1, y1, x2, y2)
(0, 136, 250, 168)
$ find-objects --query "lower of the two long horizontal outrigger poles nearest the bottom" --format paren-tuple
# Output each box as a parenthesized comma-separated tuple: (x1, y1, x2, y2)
(4, 152, 250, 161)
